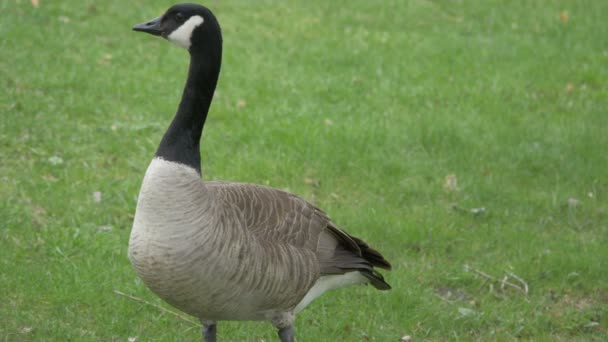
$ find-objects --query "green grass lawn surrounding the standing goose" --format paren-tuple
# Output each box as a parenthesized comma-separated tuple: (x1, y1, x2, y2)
(0, 0, 608, 341)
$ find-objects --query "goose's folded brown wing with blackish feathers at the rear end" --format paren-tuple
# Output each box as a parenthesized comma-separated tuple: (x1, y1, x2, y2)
(206, 182, 391, 290)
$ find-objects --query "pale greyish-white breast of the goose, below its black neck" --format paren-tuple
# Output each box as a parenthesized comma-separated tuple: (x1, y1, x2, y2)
(129, 158, 221, 313)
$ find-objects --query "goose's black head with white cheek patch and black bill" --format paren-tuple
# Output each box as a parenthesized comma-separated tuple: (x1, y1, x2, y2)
(133, 4, 221, 51)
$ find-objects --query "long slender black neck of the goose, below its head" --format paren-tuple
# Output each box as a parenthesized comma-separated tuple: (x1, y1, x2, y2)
(156, 44, 222, 174)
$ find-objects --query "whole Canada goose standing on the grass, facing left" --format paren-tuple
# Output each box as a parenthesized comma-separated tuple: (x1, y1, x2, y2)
(129, 4, 391, 342)
